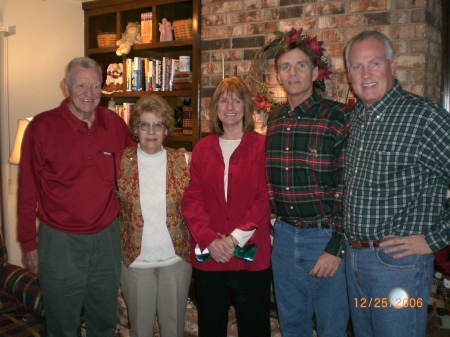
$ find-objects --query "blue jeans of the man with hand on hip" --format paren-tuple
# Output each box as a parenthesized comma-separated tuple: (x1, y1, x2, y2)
(346, 239, 434, 337)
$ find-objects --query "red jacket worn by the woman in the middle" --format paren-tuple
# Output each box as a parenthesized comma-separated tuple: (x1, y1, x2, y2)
(182, 132, 271, 271)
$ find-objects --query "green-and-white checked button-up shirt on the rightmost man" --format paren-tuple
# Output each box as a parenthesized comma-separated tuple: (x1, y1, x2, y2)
(344, 81, 450, 251)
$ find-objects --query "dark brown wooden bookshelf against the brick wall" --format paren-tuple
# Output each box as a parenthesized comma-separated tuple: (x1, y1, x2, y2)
(82, 0, 201, 150)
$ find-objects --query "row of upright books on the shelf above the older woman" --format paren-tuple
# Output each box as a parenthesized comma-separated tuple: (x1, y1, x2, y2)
(126, 56, 183, 91)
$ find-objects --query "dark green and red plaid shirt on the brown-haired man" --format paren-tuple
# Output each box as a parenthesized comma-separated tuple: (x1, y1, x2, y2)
(266, 93, 351, 256)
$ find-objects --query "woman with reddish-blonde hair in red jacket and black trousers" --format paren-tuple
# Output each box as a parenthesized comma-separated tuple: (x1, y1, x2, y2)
(182, 77, 272, 337)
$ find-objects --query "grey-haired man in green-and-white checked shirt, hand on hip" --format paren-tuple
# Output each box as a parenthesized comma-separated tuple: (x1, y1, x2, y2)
(344, 31, 450, 337)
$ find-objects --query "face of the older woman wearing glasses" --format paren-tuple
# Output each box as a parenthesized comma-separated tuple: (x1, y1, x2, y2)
(136, 112, 167, 154)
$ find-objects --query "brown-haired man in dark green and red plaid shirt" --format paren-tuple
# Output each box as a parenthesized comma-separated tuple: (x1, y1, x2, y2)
(266, 41, 350, 337)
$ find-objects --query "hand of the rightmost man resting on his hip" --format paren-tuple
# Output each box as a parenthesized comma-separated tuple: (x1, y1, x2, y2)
(380, 234, 433, 259)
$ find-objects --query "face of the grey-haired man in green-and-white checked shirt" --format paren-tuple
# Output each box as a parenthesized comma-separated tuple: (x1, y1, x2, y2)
(348, 37, 395, 108)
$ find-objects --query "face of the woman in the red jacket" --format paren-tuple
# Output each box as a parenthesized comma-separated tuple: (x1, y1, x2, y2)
(217, 92, 244, 130)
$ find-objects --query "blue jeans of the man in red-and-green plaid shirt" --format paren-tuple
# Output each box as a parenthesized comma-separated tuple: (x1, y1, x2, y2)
(272, 219, 349, 337)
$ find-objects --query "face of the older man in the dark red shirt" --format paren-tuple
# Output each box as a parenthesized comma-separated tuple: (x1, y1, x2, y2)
(63, 64, 102, 120)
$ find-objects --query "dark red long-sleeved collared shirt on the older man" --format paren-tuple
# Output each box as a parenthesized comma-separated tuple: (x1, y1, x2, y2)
(18, 98, 135, 252)
